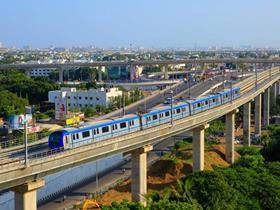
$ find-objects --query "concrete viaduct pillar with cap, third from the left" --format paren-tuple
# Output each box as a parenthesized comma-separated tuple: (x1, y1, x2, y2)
(193, 124, 209, 172)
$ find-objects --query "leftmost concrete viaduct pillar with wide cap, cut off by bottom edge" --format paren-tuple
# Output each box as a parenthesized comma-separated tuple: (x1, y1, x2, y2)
(12, 180, 45, 210)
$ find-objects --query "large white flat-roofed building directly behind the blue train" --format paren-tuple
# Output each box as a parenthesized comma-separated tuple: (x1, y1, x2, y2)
(48, 88, 122, 110)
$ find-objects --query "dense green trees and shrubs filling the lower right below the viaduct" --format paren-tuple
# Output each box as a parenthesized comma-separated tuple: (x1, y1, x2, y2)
(98, 125, 280, 210)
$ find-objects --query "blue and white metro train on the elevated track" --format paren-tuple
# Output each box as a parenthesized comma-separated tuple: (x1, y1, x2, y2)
(48, 87, 240, 149)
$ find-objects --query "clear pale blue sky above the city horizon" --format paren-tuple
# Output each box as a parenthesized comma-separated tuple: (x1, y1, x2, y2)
(0, 0, 280, 47)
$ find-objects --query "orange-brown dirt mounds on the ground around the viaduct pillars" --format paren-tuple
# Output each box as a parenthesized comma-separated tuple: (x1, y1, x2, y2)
(97, 145, 239, 205)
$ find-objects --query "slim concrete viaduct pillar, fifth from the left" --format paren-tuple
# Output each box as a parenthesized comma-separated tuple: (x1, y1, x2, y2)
(243, 102, 251, 146)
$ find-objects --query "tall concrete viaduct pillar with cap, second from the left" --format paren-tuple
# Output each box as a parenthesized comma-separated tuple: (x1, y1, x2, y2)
(131, 145, 153, 205)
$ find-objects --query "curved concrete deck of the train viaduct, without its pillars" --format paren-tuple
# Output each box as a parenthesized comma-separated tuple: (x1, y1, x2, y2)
(0, 67, 279, 189)
